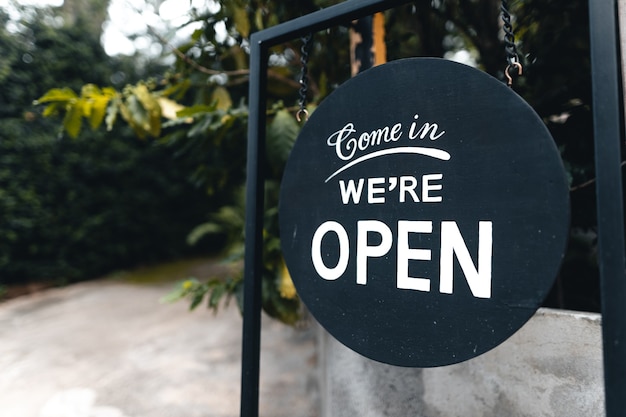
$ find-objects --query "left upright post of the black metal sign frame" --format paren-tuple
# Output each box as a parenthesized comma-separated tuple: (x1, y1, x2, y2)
(240, 35, 267, 417)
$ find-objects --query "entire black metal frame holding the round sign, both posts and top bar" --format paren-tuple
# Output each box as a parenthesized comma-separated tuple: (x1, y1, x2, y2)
(241, 0, 626, 417)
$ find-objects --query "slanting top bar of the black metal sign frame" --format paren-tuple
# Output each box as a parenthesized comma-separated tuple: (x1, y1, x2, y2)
(250, 0, 410, 47)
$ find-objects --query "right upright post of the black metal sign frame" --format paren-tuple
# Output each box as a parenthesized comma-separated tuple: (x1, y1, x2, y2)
(589, 0, 626, 417)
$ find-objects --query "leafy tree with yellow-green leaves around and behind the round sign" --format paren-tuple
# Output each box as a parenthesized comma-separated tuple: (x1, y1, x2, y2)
(35, 0, 598, 316)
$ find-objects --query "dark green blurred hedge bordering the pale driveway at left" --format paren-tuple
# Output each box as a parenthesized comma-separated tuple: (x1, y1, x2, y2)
(0, 119, 208, 284)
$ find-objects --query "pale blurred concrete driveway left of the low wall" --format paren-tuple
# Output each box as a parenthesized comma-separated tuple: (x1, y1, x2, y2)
(0, 270, 319, 417)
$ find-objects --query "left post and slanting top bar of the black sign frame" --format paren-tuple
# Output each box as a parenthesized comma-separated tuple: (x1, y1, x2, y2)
(240, 4, 409, 417)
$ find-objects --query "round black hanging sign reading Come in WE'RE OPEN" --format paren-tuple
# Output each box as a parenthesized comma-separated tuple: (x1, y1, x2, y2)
(279, 58, 569, 367)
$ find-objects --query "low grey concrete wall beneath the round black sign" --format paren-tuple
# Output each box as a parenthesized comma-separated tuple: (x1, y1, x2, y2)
(319, 309, 604, 417)
